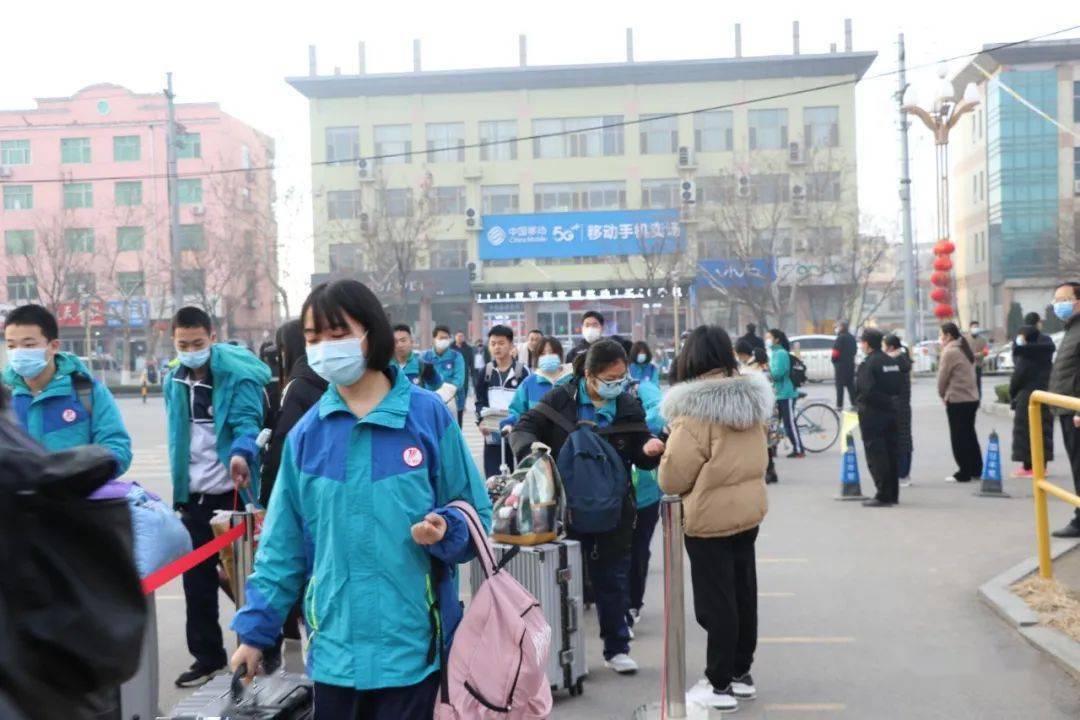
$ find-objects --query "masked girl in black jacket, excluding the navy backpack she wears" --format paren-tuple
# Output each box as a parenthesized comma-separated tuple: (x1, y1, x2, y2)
(510, 339, 664, 675)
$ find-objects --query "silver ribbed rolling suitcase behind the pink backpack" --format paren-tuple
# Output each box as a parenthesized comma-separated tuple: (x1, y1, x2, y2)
(469, 540, 589, 695)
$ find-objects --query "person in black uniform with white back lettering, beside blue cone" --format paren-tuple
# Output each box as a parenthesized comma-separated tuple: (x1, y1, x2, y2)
(855, 328, 903, 507)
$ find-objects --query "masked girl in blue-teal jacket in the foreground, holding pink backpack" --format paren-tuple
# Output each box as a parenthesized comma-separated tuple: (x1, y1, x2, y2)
(232, 280, 491, 720)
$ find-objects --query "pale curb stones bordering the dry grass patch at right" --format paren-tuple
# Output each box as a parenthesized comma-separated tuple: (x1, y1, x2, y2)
(978, 540, 1080, 680)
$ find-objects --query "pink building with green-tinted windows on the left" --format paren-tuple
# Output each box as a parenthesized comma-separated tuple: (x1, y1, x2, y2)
(0, 84, 278, 368)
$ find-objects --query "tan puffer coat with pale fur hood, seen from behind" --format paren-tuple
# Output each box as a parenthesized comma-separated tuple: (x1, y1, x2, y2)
(660, 372, 775, 538)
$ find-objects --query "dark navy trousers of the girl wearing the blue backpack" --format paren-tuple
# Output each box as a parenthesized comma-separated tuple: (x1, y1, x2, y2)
(569, 532, 630, 660)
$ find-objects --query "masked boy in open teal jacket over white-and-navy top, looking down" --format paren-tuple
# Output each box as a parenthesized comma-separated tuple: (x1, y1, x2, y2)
(162, 307, 274, 688)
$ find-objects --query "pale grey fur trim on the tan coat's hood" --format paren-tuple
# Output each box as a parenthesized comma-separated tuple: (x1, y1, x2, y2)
(661, 372, 777, 430)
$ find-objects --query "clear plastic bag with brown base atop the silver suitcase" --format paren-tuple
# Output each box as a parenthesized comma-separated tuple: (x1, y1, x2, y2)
(488, 444, 565, 545)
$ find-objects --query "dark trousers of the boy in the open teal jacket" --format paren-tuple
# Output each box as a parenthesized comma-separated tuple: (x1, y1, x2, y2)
(180, 492, 233, 669)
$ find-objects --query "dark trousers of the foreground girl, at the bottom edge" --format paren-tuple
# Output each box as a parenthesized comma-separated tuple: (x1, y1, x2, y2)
(314, 673, 438, 720)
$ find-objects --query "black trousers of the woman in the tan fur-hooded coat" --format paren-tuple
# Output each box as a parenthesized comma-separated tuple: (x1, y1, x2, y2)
(686, 528, 757, 690)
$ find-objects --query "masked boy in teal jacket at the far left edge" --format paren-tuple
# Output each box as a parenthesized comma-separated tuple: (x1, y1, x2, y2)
(3, 304, 132, 476)
